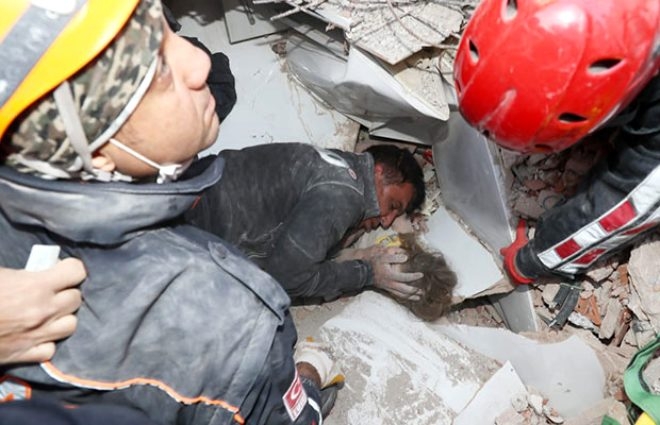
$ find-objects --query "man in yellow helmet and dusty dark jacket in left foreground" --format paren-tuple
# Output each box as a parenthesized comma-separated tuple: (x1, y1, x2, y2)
(0, 0, 339, 425)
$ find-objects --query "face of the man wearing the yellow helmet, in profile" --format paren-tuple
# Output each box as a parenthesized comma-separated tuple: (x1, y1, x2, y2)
(95, 24, 219, 177)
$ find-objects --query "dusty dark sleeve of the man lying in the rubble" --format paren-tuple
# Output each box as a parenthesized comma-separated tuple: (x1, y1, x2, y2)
(263, 184, 373, 300)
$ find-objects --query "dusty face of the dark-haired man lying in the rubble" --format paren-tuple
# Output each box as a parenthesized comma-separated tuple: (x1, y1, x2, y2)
(360, 165, 415, 232)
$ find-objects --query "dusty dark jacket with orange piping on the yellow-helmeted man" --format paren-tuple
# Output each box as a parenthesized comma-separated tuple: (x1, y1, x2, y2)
(0, 158, 319, 425)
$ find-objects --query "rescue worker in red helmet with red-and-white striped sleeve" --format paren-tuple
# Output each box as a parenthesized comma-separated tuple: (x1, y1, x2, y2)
(454, 0, 660, 284)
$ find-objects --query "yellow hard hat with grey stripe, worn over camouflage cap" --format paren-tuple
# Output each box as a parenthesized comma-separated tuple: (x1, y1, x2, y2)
(0, 0, 140, 138)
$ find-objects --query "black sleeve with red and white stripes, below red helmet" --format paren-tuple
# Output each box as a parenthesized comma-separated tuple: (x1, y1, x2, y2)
(516, 77, 660, 279)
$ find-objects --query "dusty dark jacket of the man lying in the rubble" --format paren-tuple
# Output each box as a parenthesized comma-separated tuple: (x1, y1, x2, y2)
(186, 143, 379, 300)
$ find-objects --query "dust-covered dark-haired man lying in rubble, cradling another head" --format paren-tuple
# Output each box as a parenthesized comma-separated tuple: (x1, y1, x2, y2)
(186, 143, 425, 302)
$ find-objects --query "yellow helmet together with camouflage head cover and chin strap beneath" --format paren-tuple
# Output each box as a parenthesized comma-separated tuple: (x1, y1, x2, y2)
(0, 0, 164, 179)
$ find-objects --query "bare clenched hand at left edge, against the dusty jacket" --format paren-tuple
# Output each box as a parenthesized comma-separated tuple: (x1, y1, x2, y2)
(0, 258, 86, 365)
